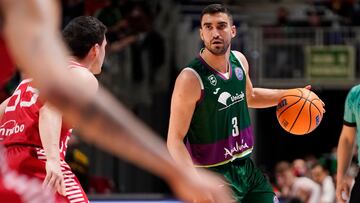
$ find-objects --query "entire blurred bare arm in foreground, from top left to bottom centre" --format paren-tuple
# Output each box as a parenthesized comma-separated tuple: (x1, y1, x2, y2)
(0, 0, 231, 203)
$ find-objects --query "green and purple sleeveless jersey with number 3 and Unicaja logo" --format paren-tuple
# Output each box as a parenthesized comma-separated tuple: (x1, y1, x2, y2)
(186, 52, 254, 167)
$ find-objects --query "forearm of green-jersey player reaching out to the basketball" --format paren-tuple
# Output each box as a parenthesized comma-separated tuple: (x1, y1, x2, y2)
(247, 88, 285, 108)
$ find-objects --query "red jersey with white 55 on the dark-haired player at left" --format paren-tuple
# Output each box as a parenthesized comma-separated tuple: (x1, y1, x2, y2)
(0, 79, 71, 158)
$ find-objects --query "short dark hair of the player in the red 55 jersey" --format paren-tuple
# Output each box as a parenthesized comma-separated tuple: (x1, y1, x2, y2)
(62, 16, 107, 59)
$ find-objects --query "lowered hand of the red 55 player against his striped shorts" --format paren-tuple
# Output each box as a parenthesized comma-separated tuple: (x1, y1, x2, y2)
(43, 160, 66, 196)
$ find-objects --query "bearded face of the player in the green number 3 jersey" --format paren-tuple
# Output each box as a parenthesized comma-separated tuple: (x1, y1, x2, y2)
(200, 13, 235, 55)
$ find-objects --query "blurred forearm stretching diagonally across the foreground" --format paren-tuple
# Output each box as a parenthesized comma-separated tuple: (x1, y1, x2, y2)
(48, 86, 190, 182)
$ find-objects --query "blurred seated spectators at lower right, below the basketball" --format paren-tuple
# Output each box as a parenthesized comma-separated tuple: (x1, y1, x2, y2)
(269, 148, 358, 203)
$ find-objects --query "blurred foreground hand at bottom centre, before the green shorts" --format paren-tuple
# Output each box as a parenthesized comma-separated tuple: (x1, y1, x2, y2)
(170, 170, 235, 203)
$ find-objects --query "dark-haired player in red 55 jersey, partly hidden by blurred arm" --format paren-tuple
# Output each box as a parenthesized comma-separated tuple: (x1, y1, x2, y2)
(0, 16, 106, 202)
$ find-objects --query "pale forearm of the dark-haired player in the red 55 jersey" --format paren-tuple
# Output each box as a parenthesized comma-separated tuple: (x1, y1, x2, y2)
(39, 105, 62, 161)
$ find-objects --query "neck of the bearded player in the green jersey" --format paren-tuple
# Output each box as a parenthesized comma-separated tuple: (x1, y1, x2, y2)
(200, 49, 230, 73)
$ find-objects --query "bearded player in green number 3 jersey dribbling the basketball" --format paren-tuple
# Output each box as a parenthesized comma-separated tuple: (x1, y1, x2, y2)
(167, 4, 324, 203)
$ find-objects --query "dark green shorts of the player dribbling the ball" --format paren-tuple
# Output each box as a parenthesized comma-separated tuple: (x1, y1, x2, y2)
(209, 158, 278, 203)
